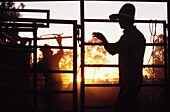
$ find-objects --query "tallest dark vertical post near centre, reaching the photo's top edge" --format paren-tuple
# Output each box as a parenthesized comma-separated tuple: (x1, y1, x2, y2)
(80, 0, 85, 112)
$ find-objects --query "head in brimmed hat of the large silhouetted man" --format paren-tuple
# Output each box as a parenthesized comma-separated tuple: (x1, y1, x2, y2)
(109, 3, 135, 28)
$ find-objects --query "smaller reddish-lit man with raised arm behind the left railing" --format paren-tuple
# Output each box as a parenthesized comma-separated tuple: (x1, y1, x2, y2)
(35, 36, 63, 111)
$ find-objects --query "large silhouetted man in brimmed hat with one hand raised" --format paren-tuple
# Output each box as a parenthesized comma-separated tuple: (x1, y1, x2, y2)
(93, 3, 146, 112)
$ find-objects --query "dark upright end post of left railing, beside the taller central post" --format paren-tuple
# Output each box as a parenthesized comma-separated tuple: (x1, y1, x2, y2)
(73, 21, 77, 112)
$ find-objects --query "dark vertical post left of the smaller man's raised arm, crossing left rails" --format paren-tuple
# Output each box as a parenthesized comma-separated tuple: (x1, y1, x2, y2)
(33, 22, 37, 112)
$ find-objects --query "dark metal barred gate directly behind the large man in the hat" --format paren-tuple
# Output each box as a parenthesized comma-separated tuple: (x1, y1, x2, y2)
(81, 19, 168, 112)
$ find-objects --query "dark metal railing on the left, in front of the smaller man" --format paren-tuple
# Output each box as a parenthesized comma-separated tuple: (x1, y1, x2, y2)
(0, 9, 77, 112)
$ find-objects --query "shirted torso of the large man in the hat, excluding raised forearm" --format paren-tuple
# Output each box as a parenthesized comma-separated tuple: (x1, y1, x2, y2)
(119, 27, 146, 86)
